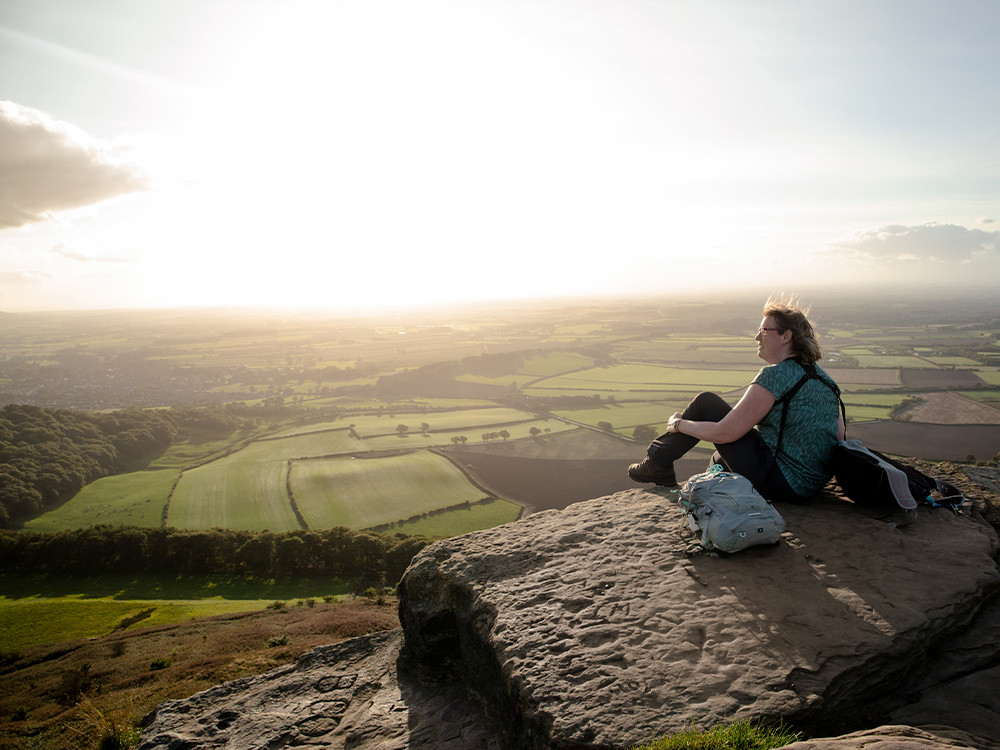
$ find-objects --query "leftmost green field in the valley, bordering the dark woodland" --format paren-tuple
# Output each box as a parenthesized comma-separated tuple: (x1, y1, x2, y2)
(24, 469, 179, 532)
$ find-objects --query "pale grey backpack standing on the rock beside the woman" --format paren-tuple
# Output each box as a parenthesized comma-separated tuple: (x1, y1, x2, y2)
(678, 471, 785, 552)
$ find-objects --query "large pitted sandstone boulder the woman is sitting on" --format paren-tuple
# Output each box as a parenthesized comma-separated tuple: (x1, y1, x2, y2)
(400, 489, 1000, 748)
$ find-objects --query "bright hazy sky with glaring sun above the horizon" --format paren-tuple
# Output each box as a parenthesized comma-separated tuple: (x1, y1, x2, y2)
(0, 0, 1000, 312)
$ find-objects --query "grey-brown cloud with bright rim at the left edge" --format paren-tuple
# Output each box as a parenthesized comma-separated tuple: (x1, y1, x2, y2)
(0, 101, 146, 230)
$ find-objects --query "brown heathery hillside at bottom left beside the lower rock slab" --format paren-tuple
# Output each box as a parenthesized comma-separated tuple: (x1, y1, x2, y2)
(0, 587, 399, 750)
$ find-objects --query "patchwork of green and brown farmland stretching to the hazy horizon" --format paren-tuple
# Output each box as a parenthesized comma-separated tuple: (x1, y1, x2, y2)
(3, 288, 1000, 536)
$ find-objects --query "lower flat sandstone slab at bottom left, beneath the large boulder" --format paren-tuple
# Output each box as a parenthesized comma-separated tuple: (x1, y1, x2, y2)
(139, 629, 500, 750)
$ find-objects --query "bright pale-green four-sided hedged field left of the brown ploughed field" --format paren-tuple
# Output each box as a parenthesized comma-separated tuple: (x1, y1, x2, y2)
(291, 451, 485, 529)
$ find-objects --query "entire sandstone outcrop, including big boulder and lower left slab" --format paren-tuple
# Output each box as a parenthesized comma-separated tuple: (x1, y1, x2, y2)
(140, 482, 1000, 750)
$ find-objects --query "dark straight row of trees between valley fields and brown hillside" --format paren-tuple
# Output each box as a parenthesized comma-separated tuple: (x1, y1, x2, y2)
(0, 526, 430, 584)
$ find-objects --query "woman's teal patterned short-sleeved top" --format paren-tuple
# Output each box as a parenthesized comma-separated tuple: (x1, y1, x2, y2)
(753, 359, 840, 497)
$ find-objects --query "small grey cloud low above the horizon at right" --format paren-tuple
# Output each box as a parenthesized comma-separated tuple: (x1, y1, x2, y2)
(830, 223, 1000, 263)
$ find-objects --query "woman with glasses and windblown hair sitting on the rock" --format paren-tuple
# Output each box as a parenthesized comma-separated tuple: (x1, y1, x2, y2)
(628, 297, 844, 500)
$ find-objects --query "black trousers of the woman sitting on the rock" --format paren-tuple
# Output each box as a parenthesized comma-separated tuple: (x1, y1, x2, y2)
(647, 392, 803, 501)
